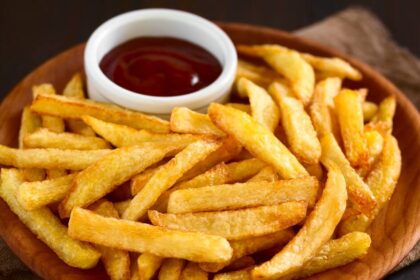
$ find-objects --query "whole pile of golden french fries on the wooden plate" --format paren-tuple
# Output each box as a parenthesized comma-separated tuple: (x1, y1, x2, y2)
(0, 45, 401, 280)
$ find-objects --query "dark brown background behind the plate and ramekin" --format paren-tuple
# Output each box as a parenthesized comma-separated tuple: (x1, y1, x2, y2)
(0, 0, 420, 280)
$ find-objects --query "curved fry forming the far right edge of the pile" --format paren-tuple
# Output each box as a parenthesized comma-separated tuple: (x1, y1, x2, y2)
(339, 135, 401, 234)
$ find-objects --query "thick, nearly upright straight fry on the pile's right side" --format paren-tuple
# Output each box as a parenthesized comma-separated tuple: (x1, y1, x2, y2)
(334, 89, 368, 167)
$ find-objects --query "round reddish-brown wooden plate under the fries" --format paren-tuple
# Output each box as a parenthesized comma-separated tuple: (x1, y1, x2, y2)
(0, 23, 420, 280)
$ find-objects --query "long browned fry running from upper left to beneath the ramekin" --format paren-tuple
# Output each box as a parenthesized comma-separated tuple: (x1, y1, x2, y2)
(31, 94, 169, 133)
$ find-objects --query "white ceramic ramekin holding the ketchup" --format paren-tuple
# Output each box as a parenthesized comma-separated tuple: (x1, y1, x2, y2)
(84, 9, 237, 115)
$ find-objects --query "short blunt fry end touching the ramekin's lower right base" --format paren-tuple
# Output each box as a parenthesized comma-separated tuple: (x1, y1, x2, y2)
(170, 107, 225, 137)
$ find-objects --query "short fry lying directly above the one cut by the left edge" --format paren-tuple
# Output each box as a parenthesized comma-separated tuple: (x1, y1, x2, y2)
(23, 128, 111, 150)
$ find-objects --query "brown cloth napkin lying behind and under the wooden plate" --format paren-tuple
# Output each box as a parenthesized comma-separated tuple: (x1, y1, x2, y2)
(0, 5, 420, 280)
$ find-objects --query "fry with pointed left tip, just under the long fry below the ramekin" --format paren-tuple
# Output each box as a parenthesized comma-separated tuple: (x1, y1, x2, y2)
(82, 116, 204, 147)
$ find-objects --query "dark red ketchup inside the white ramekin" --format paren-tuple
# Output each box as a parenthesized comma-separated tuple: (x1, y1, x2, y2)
(99, 37, 222, 96)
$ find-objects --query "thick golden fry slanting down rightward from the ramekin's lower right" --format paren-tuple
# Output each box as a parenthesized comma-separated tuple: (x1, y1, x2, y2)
(209, 103, 308, 179)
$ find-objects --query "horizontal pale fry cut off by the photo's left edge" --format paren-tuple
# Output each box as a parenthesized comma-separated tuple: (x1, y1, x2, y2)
(0, 145, 111, 170)
